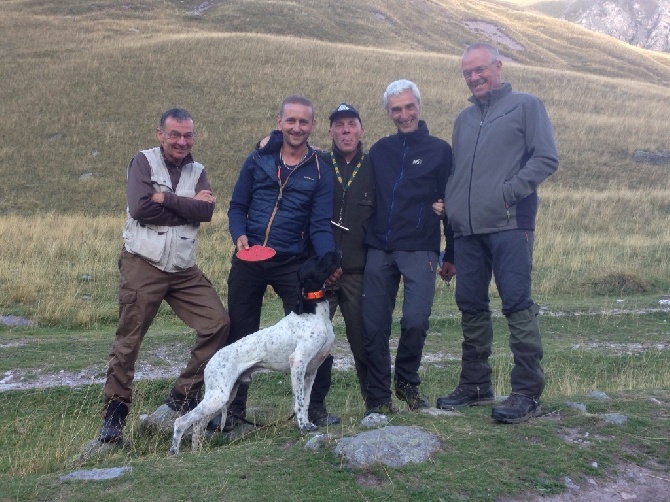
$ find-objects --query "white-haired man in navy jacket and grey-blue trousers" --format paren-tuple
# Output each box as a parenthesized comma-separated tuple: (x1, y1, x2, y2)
(363, 80, 454, 416)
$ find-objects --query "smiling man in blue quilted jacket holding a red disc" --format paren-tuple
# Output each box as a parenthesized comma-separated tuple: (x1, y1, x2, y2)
(224, 96, 341, 430)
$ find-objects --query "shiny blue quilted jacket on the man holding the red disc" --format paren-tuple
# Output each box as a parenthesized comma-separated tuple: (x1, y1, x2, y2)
(228, 131, 335, 256)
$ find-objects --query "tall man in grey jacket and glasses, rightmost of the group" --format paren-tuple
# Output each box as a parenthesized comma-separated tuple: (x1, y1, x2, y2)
(437, 43, 558, 423)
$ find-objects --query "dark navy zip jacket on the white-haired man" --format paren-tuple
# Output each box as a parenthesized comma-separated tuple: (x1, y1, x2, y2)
(365, 120, 453, 256)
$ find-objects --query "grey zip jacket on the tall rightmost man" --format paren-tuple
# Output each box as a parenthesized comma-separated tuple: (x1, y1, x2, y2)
(444, 82, 558, 237)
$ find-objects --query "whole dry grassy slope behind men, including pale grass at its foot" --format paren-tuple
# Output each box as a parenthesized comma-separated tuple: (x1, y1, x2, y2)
(0, 0, 670, 324)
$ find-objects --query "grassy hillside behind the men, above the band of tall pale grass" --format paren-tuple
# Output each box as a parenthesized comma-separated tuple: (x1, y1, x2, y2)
(0, 0, 670, 215)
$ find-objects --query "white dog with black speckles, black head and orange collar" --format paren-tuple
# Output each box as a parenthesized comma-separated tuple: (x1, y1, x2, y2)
(170, 251, 342, 455)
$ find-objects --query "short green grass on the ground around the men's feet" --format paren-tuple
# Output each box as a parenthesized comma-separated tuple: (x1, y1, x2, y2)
(0, 300, 670, 501)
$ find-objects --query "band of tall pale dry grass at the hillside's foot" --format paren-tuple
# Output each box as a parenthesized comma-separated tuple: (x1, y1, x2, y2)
(0, 184, 670, 325)
